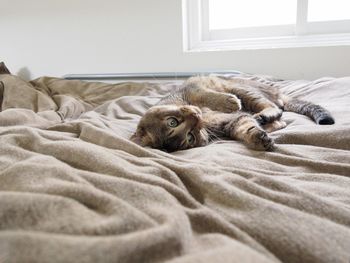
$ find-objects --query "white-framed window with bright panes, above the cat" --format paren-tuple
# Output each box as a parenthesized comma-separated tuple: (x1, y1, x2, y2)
(183, 0, 350, 50)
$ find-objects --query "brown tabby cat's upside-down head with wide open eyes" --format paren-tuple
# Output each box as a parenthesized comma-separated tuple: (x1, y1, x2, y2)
(131, 105, 208, 152)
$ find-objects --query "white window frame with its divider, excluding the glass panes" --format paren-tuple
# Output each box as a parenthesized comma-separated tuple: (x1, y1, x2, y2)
(182, 0, 350, 51)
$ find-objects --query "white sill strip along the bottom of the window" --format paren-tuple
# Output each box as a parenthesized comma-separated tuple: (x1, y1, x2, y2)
(184, 33, 350, 52)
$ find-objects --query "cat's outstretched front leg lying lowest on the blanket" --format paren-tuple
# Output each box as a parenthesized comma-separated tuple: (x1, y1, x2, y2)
(225, 113, 274, 151)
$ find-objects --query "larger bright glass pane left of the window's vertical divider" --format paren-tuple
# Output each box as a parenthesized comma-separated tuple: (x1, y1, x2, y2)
(209, 0, 296, 30)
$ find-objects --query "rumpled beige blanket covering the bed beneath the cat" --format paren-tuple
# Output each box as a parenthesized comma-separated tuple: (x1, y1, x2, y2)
(0, 71, 350, 263)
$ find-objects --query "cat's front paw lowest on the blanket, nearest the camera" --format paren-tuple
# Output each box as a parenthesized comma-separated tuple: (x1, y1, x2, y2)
(247, 126, 274, 151)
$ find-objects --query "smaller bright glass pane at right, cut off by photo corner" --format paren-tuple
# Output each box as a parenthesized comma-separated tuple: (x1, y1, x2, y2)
(308, 0, 350, 22)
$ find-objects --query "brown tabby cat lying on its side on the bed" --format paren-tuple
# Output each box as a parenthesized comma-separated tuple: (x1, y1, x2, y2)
(131, 76, 334, 152)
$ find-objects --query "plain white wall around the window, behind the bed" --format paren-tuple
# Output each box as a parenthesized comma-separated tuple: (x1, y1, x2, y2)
(0, 0, 350, 79)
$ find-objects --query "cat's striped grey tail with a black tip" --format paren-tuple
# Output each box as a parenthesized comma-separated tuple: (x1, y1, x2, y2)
(283, 97, 334, 125)
